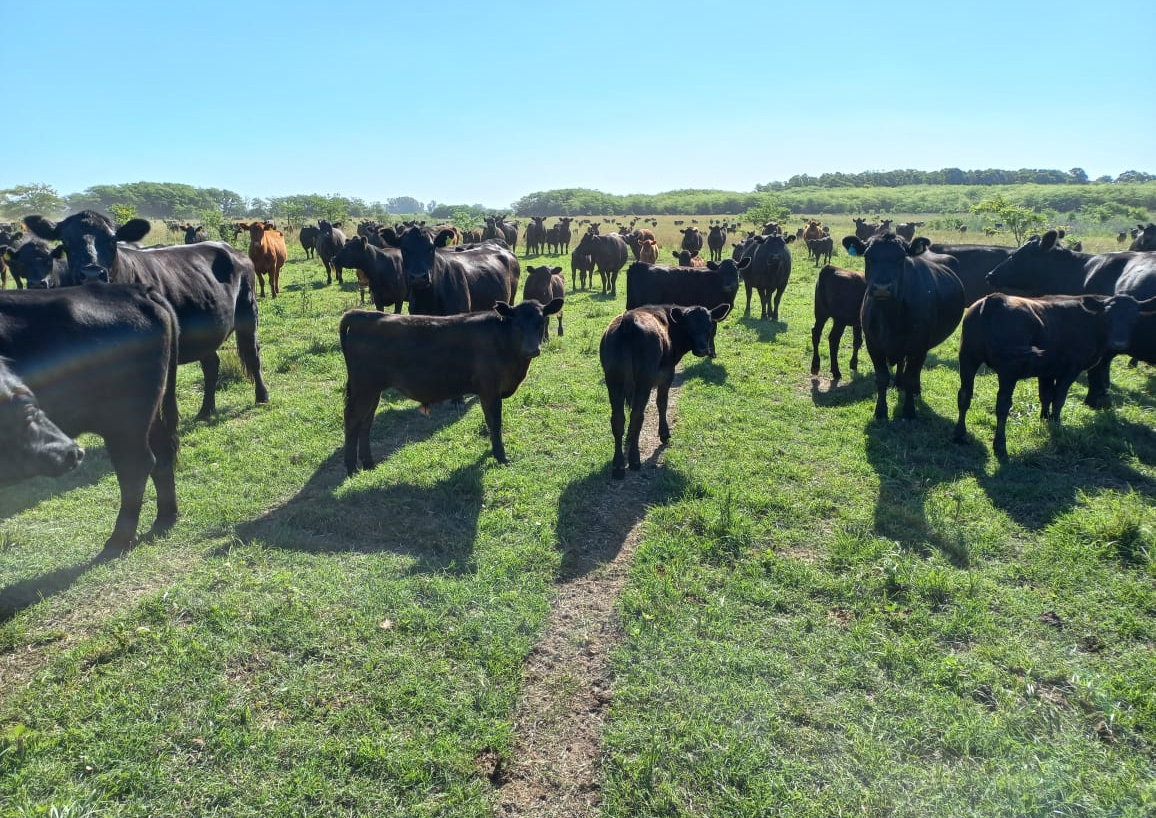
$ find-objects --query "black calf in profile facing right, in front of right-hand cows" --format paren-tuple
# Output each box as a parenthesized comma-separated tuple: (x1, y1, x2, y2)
(955, 292, 1140, 458)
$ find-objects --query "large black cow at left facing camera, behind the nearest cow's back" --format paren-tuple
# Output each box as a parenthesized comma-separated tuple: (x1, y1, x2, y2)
(24, 210, 269, 418)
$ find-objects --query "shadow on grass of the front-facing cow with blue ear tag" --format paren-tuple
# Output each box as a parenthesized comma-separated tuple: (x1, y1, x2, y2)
(865, 406, 983, 567)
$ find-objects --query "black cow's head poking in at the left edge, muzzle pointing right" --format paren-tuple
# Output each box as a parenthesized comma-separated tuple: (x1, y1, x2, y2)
(0, 360, 84, 483)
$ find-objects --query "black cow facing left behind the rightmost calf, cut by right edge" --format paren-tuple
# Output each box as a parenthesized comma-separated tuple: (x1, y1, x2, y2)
(987, 230, 1156, 407)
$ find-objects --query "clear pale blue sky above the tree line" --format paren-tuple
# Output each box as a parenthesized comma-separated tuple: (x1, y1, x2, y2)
(0, 0, 1156, 207)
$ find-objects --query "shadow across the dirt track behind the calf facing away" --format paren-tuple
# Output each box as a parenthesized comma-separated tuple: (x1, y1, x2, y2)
(555, 452, 688, 582)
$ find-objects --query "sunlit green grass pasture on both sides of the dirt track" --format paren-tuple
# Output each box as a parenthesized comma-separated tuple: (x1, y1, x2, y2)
(0, 216, 1156, 817)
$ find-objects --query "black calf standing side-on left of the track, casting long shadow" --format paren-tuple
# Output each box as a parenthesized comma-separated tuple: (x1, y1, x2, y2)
(340, 298, 562, 475)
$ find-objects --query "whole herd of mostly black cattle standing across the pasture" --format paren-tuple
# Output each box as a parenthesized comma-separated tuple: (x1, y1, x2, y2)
(0, 211, 1156, 549)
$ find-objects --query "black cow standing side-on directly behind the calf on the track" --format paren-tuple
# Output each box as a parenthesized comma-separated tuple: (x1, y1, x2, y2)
(627, 259, 750, 358)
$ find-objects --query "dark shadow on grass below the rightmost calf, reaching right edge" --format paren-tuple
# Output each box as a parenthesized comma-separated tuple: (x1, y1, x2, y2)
(973, 412, 1156, 530)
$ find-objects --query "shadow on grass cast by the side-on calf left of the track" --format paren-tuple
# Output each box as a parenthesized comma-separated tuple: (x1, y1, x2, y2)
(237, 403, 491, 574)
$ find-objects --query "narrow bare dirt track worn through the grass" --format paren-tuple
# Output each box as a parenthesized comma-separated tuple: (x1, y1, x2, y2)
(494, 385, 681, 818)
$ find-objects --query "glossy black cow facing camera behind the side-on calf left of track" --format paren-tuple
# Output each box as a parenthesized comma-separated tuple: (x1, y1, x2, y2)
(381, 226, 521, 315)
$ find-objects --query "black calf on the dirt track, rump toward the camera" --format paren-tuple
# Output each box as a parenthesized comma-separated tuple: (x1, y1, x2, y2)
(599, 304, 731, 479)
